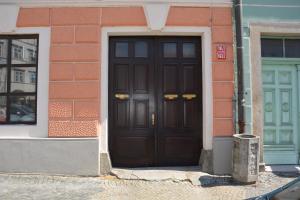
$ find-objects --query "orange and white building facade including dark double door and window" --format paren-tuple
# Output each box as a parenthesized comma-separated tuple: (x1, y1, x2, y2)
(0, 0, 234, 175)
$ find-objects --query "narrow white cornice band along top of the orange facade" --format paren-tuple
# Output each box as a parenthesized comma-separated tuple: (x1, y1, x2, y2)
(0, 0, 232, 7)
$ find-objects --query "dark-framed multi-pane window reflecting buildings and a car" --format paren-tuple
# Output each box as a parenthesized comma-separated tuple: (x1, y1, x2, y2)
(0, 35, 38, 124)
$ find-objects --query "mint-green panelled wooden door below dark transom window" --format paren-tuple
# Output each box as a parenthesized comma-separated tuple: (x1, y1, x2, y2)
(262, 64, 298, 164)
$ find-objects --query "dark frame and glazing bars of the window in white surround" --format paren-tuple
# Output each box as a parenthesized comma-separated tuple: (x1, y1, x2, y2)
(0, 34, 39, 126)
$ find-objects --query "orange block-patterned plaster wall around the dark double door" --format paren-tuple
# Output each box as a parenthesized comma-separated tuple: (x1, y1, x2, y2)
(17, 6, 234, 137)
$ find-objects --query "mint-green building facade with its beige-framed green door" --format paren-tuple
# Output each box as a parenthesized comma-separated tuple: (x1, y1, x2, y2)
(242, 0, 300, 164)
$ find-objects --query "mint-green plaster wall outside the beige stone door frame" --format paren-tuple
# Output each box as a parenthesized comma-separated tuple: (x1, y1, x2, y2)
(242, 0, 300, 134)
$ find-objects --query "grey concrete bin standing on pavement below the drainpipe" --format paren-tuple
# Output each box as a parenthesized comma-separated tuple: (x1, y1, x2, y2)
(232, 134, 259, 183)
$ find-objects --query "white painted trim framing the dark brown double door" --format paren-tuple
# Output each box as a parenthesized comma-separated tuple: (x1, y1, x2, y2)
(100, 26, 213, 153)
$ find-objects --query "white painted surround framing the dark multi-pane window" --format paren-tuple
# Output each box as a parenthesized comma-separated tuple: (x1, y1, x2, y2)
(0, 10, 50, 138)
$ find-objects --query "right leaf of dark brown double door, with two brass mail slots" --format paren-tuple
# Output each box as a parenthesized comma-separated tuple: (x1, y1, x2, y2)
(157, 38, 202, 166)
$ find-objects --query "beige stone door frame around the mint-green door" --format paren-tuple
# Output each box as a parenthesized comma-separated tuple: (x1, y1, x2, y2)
(249, 22, 300, 166)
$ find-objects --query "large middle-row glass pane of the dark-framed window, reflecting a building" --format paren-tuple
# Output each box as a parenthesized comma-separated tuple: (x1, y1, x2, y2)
(10, 67, 36, 93)
